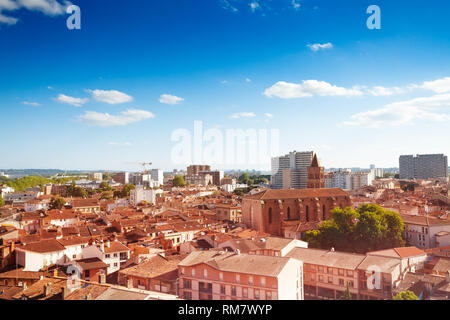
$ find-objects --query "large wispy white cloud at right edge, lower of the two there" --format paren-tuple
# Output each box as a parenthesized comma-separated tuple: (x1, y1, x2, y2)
(343, 94, 450, 128)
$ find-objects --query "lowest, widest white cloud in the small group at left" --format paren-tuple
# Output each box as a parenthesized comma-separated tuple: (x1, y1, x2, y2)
(78, 109, 155, 127)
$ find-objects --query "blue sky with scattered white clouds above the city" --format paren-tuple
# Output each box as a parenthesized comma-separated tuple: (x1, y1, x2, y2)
(0, 0, 450, 170)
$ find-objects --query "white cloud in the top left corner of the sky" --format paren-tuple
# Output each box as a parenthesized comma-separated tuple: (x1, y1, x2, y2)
(0, 0, 72, 25)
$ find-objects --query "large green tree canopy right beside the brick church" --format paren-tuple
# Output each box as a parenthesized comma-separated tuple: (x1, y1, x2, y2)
(303, 204, 405, 253)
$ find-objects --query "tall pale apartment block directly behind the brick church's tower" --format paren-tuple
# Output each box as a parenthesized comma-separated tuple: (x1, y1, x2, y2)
(271, 151, 314, 189)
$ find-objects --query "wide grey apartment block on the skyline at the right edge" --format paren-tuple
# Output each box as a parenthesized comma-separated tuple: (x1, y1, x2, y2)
(399, 154, 448, 179)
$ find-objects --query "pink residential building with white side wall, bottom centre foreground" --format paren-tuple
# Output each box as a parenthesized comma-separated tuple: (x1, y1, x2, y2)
(178, 251, 304, 301)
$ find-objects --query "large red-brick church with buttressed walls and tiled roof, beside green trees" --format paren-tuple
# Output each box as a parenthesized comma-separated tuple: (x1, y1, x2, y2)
(242, 189, 352, 239)
